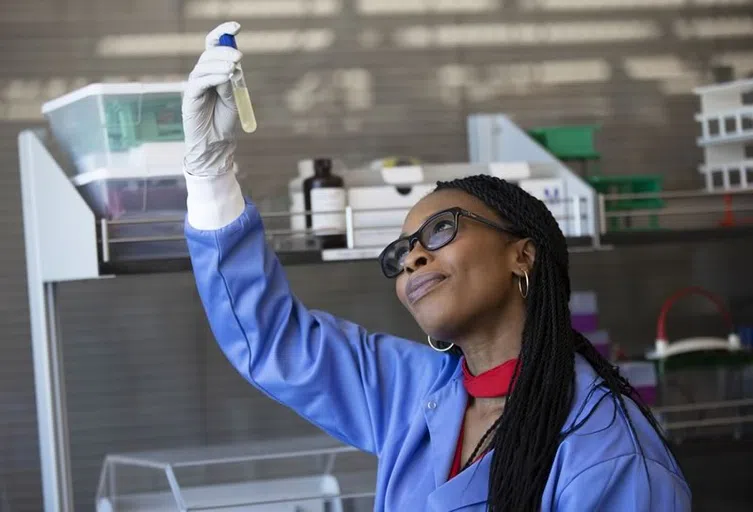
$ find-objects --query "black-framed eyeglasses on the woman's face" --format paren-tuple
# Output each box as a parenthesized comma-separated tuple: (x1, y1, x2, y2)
(379, 208, 523, 279)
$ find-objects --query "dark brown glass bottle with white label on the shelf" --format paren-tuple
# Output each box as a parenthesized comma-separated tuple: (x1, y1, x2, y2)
(303, 158, 347, 249)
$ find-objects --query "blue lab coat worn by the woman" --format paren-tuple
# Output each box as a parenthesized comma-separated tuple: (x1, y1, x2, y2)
(186, 203, 690, 512)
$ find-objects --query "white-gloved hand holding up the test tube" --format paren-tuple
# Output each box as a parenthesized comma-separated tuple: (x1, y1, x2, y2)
(182, 22, 242, 176)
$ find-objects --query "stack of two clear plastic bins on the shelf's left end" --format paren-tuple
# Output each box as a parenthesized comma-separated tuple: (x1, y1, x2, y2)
(42, 82, 191, 259)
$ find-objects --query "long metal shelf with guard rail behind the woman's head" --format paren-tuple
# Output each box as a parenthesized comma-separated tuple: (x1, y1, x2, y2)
(86, 189, 753, 275)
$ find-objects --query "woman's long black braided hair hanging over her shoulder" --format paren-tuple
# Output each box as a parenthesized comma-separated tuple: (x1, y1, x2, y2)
(437, 175, 669, 512)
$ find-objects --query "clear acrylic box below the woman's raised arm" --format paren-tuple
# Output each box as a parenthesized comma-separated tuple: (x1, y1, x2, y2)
(96, 436, 376, 512)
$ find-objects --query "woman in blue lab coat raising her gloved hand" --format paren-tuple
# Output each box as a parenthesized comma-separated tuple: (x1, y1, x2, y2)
(183, 23, 690, 512)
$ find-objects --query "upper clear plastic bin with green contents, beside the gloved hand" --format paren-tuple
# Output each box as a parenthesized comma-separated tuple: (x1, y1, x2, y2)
(42, 82, 184, 173)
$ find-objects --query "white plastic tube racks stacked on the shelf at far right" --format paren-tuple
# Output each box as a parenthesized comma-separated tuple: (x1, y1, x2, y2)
(694, 79, 753, 191)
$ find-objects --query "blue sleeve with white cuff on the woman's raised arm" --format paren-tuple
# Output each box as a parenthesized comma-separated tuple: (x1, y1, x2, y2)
(186, 175, 449, 454)
